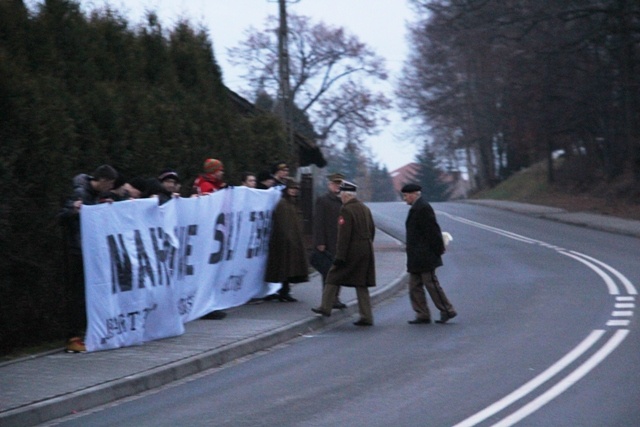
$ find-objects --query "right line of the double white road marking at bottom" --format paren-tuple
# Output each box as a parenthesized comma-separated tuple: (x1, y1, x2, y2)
(493, 329, 629, 427)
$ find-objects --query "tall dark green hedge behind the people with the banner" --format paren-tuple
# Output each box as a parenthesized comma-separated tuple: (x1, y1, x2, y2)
(0, 0, 289, 353)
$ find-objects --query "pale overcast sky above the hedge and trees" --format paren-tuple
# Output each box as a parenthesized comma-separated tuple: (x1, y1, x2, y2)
(72, 0, 417, 171)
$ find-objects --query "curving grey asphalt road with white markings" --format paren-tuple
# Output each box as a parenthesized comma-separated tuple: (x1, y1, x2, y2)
(48, 203, 640, 427)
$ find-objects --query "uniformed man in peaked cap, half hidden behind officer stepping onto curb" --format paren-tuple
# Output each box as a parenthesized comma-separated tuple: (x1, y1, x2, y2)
(311, 173, 346, 309)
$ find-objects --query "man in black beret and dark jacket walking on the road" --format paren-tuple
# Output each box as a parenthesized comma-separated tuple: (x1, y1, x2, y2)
(401, 184, 458, 325)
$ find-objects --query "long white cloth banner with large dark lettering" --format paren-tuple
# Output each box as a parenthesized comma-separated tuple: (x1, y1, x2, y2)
(81, 187, 281, 351)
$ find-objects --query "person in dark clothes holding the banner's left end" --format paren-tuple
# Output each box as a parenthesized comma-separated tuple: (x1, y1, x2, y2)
(58, 165, 118, 353)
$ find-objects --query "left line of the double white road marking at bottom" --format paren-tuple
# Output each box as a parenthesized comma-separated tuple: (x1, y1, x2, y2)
(454, 329, 605, 427)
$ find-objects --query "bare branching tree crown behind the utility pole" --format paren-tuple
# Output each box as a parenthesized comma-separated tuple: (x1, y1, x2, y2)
(229, 14, 391, 148)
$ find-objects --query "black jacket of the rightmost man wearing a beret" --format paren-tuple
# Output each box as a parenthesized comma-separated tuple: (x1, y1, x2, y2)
(405, 197, 444, 273)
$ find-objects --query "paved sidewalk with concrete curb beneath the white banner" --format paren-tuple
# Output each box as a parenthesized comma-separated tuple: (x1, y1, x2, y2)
(0, 231, 405, 427)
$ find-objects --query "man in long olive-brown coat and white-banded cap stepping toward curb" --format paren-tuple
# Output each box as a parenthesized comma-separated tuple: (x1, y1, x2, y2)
(311, 181, 376, 326)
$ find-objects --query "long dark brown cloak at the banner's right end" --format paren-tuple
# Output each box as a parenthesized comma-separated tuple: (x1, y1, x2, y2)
(264, 194, 309, 283)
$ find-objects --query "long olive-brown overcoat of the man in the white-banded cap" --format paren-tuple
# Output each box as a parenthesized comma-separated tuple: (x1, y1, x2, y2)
(326, 199, 376, 287)
